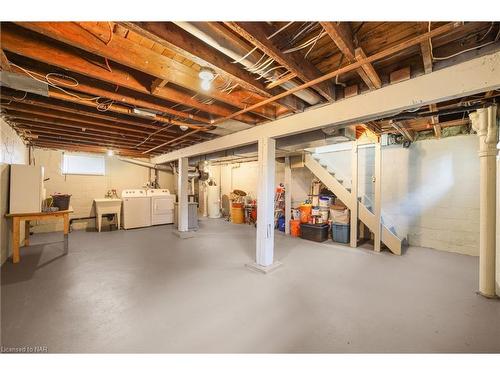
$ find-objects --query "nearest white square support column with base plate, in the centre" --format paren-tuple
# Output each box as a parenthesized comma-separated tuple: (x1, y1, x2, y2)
(247, 137, 281, 273)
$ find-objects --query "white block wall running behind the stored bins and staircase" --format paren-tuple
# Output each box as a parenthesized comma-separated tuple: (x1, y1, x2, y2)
(208, 135, 484, 255)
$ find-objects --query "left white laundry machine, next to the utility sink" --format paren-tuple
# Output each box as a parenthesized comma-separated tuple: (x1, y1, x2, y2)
(122, 189, 151, 229)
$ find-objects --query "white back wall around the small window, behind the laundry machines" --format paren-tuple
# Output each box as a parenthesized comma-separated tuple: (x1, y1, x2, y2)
(33, 149, 175, 232)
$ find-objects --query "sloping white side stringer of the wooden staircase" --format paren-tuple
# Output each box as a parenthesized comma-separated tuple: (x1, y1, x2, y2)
(305, 153, 402, 255)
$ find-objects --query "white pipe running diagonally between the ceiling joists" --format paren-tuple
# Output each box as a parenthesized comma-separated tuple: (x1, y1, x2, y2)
(174, 22, 321, 105)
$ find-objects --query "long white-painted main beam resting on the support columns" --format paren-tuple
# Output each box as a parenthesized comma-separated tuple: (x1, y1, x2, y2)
(154, 37, 492, 163)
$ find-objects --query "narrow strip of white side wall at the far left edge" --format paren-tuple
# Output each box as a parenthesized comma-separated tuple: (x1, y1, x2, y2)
(0, 118, 28, 264)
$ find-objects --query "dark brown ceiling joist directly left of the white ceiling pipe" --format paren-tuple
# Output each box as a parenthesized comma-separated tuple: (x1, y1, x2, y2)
(122, 22, 276, 97)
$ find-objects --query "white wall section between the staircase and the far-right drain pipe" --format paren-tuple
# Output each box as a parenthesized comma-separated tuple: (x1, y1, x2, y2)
(382, 135, 479, 255)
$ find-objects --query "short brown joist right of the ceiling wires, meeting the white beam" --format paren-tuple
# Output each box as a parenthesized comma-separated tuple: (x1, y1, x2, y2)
(320, 22, 377, 90)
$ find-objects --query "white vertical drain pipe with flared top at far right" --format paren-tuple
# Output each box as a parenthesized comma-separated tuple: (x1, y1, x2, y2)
(469, 106, 498, 298)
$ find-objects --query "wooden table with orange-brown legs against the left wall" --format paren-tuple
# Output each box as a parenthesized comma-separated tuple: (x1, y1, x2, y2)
(5, 207, 73, 263)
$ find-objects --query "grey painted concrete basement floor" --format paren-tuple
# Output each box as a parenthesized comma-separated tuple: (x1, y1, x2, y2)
(1, 220, 500, 353)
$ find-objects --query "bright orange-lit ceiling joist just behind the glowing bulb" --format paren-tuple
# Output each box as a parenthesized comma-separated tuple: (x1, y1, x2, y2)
(16, 22, 275, 119)
